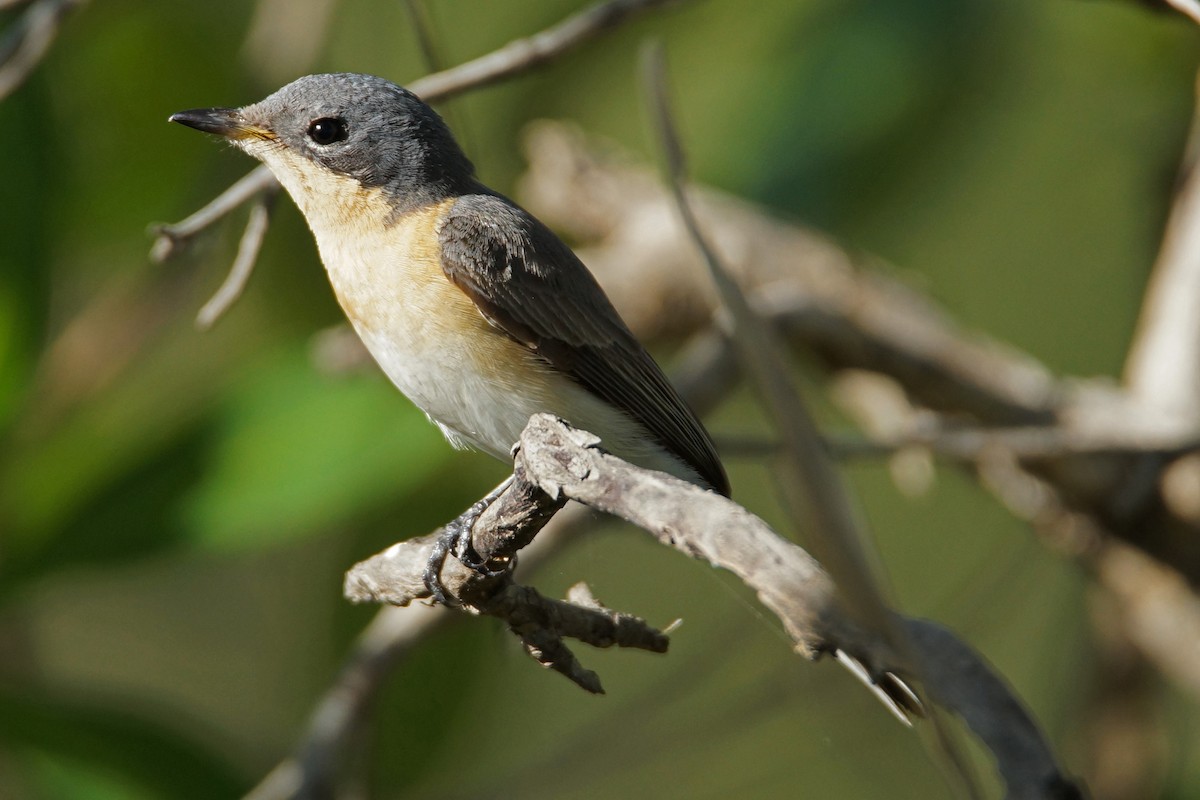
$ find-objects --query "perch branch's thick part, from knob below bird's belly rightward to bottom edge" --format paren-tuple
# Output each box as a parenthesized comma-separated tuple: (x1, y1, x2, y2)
(518, 415, 1081, 800)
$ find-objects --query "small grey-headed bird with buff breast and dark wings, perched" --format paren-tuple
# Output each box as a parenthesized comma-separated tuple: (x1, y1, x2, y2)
(169, 73, 730, 602)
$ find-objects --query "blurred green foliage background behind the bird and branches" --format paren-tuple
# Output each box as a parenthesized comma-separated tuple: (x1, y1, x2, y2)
(0, 0, 1200, 800)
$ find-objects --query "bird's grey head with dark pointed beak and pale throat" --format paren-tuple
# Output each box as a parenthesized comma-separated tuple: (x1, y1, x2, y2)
(170, 73, 474, 212)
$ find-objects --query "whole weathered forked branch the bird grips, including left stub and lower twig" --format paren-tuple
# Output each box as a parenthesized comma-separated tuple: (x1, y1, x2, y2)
(347, 415, 1079, 799)
